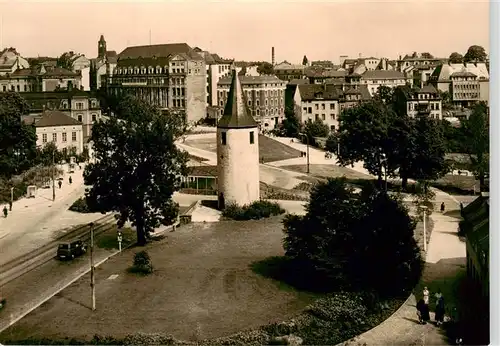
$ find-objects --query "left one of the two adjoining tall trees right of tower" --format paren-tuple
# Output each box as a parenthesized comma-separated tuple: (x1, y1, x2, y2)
(337, 99, 397, 186)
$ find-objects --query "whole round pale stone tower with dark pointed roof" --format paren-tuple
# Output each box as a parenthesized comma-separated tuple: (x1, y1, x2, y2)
(217, 70, 260, 208)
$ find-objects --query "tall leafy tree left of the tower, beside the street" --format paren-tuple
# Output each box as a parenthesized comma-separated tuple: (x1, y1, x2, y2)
(84, 96, 188, 245)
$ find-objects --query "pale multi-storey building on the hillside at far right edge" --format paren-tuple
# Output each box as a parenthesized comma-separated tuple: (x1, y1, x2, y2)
(429, 63, 490, 107)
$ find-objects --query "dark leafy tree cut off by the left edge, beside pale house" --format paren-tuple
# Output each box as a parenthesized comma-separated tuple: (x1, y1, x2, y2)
(0, 92, 37, 178)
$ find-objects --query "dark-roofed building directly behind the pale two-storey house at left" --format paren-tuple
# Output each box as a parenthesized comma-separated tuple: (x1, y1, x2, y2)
(21, 89, 102, 143)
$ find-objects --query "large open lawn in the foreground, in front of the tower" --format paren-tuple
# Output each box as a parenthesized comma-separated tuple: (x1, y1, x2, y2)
(0, 217, 314, 344)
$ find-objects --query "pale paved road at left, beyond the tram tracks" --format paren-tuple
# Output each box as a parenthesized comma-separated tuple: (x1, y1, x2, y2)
(0, 167, 94, 265)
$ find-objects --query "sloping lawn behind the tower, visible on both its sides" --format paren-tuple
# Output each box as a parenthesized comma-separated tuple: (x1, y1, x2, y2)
(184, 134, 300, 162)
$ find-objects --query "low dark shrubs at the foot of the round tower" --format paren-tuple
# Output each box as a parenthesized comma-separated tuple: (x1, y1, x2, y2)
(222, 201, 285, 221)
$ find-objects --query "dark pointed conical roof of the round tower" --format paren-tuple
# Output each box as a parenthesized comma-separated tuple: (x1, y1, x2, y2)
(217, 69, 257, 129)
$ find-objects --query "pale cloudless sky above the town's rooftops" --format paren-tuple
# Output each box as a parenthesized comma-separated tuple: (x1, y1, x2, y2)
(0, 0, 489, 63)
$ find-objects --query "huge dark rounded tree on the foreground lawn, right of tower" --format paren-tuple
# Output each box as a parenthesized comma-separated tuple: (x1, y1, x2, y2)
(284, 178, 421, 294)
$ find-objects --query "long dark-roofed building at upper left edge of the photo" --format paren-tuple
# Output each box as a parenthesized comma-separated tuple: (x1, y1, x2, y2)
(0, 64, 82, 92)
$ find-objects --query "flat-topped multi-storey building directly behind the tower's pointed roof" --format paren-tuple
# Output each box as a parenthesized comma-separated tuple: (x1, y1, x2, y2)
(218, 76, 286, 128)
